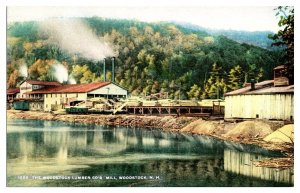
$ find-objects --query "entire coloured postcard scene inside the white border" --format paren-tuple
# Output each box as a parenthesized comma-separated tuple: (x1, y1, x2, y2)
(6, 5, 294, 187)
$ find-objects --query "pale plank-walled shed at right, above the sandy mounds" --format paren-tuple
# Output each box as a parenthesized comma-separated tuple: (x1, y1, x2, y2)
(225, 80, 294, 120)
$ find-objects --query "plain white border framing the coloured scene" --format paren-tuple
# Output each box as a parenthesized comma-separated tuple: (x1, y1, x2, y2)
(0, 0, 299, 193)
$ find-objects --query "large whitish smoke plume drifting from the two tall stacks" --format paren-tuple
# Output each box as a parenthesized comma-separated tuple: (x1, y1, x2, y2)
(41, 19, 114, 61)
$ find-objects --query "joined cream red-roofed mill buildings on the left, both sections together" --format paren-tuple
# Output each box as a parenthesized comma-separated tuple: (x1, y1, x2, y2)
(7, 80, 128, 111)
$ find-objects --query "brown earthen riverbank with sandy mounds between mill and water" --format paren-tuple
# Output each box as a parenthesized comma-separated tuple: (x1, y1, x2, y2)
(7, 110, 294, 168)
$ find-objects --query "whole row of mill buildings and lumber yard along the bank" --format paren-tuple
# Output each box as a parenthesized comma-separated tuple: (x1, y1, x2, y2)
(7, 66, 294, 121)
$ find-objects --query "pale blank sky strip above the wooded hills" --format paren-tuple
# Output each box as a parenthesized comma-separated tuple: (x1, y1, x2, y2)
(7, 6, 279, 32)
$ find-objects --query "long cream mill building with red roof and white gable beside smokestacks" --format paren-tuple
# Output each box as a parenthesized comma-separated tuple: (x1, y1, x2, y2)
(25, 82, 128, 111)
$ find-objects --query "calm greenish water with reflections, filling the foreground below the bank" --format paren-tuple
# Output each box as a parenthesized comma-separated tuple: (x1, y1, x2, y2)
(7, 120, 293, 187)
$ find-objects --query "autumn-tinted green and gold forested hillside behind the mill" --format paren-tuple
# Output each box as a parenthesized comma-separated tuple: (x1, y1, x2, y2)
(7, 17, 282, 99)
